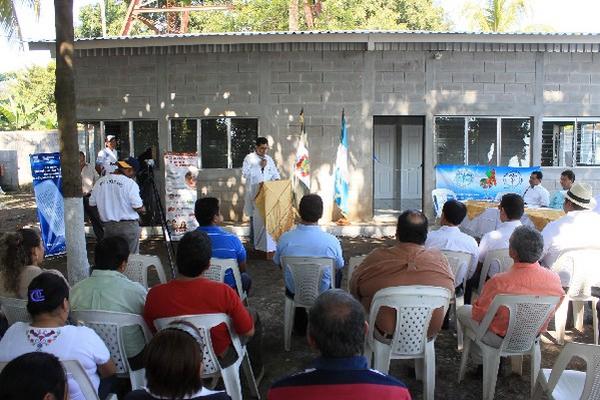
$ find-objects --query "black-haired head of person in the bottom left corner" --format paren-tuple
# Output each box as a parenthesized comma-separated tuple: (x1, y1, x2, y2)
(0, 352, 69, 400)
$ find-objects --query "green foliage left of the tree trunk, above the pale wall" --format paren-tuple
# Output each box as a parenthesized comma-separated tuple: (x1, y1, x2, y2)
(0, 62, 57, 130)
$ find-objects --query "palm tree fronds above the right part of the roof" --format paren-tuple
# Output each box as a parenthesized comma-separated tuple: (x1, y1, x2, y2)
(466, 0, 526, 32)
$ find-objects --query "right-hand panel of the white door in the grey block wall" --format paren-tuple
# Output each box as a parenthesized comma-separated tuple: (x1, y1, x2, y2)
(400, 125, 423, 200)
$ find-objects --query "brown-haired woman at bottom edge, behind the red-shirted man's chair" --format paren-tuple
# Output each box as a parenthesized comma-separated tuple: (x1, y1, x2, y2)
(125, 321, 231, 400)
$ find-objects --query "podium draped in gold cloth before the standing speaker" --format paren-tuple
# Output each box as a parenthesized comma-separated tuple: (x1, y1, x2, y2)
(254, 180, 294, 253)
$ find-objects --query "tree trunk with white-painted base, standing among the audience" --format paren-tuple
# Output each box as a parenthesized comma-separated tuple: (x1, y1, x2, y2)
(54, 0, 89, 285)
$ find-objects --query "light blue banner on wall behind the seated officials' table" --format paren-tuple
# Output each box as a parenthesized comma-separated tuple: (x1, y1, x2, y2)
(435, 165, 540, 200)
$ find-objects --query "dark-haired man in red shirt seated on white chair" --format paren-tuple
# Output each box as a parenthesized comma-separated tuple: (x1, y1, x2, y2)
(144, 231, 263, 380)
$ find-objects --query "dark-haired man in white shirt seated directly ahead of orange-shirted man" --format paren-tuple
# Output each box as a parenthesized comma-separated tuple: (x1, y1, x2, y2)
(465, 193, 525, 304)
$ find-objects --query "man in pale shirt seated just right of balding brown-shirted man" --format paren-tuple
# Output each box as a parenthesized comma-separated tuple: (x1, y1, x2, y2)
(425, 200, 479, 288)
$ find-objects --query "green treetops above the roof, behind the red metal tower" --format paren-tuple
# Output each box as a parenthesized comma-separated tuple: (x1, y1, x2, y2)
(76, 0, 448, 37)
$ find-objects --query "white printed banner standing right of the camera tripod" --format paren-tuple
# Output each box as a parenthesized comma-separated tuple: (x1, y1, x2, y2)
(165, 152, 198, 240)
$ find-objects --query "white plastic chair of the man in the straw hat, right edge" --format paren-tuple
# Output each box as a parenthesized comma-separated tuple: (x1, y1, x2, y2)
(552, 249, 600, 344)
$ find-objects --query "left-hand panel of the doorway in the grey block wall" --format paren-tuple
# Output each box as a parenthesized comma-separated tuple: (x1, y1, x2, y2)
(373, 125, 396, 199)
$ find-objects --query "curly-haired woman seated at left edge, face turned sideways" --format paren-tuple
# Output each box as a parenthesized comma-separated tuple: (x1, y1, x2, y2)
(0, 228, 64, 299)
